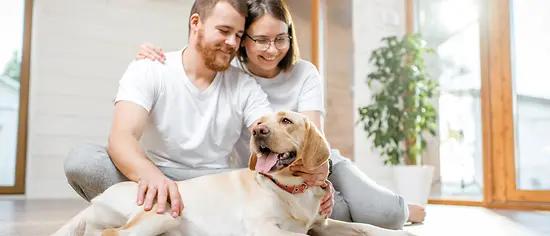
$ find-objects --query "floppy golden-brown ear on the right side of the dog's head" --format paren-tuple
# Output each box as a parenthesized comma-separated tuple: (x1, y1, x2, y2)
(298, 118, 330, 169)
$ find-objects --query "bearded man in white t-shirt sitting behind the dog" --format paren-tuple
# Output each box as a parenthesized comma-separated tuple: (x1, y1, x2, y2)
(65, 0, 332, 221)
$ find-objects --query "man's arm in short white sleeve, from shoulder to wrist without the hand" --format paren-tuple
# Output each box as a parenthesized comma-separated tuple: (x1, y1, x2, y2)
(107, 60, 161, 182)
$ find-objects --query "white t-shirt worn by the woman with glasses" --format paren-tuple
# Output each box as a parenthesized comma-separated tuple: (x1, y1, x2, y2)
(232, 59, 325, 167)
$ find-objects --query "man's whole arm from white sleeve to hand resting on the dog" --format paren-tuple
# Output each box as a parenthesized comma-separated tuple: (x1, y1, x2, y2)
(107, 60, 183, 217)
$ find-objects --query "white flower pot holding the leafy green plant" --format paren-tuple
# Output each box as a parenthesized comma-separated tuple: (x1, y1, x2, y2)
(393, 165, 434, 206)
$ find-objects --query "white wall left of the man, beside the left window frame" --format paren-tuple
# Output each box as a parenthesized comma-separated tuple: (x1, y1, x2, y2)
(26, 0, 192, 198)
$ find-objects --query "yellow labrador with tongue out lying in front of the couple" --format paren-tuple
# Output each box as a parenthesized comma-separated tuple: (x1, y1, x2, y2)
(53, 111, 413, 236)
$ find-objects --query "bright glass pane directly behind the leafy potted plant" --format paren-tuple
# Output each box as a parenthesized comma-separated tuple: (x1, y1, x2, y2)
(418, 0, 485, 202)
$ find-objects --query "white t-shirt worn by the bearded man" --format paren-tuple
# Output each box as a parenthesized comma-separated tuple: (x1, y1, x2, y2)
(116, 49, 272, 168)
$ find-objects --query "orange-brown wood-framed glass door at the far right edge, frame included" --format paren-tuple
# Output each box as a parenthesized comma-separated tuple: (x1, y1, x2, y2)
(486, 0, 550, 203)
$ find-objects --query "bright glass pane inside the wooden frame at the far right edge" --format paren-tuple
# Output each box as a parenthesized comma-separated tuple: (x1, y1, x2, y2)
(507, 0, 550, 202)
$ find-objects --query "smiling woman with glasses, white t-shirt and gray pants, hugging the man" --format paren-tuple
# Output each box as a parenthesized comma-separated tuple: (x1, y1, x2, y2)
(136, 0, 425, 229)
